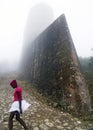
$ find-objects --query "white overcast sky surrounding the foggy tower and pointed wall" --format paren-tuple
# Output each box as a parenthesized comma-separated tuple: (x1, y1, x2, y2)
(0, 0, 93, 62)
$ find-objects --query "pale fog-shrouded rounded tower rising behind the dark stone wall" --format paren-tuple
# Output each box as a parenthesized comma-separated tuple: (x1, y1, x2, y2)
(24, 3, 54, 44)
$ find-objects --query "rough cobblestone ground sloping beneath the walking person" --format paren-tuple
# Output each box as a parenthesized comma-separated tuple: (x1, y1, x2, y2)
(0, 74, 93, 130)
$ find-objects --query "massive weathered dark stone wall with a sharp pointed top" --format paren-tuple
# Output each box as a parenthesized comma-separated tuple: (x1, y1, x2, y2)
(22, 15, 91, 112)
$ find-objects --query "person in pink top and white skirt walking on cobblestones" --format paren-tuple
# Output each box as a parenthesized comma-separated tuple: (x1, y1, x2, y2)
(8, 80, 30, 130)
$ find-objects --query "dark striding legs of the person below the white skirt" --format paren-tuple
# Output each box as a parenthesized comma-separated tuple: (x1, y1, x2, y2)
(8, 111, 28, 130)
